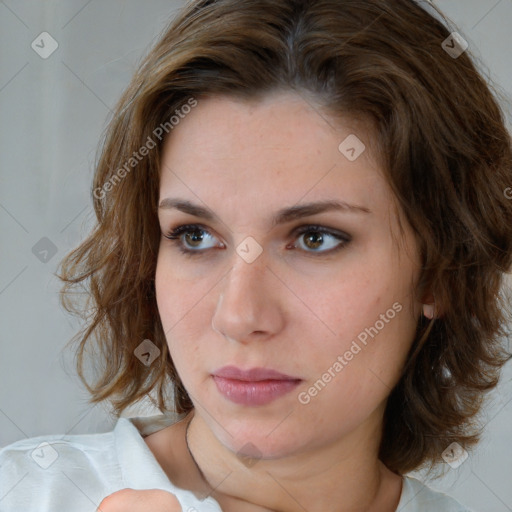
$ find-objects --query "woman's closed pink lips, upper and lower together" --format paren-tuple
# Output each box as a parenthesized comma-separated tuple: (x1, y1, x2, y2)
(213, 366, 302, 406)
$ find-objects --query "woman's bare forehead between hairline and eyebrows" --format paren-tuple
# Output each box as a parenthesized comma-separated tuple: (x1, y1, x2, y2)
(160, 93, 391, 218)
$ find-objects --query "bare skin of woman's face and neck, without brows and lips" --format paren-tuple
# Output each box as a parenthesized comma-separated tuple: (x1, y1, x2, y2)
(103, 93, 422, 512)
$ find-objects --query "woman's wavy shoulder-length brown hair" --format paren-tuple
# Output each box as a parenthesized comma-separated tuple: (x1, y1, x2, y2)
(59, 0, 512, 474)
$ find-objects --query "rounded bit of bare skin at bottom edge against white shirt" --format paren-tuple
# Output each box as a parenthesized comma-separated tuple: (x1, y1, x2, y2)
(97, 489, 182, 512)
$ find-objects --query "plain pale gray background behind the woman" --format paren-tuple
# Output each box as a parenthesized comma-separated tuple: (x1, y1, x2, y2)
(0, 0, 512, 512)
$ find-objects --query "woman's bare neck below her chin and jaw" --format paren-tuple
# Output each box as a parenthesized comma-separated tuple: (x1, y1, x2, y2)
(183, 412, 401, 512)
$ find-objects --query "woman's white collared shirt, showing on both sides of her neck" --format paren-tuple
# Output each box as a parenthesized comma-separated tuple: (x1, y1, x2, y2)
(0, 414, 471, 512)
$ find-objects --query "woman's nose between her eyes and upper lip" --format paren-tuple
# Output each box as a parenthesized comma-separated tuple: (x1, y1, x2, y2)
(212, 249, 284, 343)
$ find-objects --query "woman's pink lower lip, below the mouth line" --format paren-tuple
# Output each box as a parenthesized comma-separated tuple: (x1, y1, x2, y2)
(213, 375, 301, 406)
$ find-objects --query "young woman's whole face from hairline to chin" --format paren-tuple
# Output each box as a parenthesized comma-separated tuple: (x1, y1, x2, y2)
(156, 93, 421, 458)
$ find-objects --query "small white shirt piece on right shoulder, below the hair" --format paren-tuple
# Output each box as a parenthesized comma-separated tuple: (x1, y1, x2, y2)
(396, 476, 474, 512)
